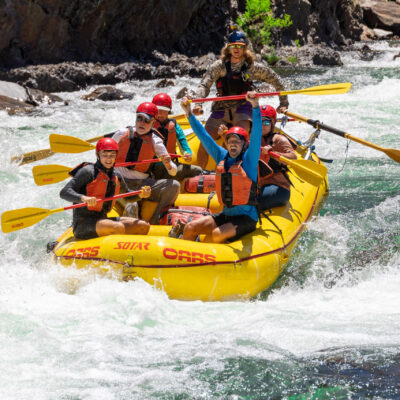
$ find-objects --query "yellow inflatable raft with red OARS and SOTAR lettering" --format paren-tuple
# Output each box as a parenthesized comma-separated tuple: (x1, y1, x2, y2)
(53, 133, 328, 301)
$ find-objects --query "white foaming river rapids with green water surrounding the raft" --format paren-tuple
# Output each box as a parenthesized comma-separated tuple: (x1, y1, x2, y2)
(0, 42, 400, 400)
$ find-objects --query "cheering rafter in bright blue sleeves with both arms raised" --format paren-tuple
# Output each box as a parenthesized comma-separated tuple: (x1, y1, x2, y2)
(181, 92, 261, 243)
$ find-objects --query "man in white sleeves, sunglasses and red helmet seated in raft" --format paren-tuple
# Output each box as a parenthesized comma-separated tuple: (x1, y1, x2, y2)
(113, 102, 180, 224)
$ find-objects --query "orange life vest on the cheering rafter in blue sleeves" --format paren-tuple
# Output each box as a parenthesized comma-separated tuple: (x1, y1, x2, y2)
(215, 159, 257, 207)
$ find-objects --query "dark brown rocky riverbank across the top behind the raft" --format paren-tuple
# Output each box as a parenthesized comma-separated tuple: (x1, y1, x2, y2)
(0, 0, 400, 109)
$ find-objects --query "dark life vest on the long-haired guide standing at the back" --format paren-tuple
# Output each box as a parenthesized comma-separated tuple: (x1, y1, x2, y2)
(216, 61, 253, 96)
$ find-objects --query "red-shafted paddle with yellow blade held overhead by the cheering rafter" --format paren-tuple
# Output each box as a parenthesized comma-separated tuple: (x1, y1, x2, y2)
(189, 82, 351, 103)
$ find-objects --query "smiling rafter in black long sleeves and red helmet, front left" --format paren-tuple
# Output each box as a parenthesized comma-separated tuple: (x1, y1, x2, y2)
(60, 138, 150, 239)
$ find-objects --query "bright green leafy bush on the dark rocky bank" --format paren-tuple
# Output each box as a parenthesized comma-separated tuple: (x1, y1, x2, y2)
(236, 0, 293, 46)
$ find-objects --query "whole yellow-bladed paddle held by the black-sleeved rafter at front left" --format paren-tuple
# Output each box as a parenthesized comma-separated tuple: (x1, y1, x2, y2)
(1, 190, 141, 233)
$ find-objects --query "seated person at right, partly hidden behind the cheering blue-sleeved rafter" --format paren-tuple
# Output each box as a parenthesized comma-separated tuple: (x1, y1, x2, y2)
(258, 106, 297, 211)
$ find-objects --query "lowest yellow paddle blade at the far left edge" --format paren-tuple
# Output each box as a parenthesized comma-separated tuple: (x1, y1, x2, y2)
(1, 207, 51, 233)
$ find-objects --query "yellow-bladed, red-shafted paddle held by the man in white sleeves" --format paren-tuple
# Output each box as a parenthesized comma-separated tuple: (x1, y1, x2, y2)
(32, 154, 182, 186)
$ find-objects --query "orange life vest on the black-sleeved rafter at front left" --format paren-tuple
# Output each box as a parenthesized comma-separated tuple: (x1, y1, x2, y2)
(69, 163, 120, 214)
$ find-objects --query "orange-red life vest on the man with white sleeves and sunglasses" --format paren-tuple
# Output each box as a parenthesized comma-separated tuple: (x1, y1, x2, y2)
(116, 126, 156, 173)
